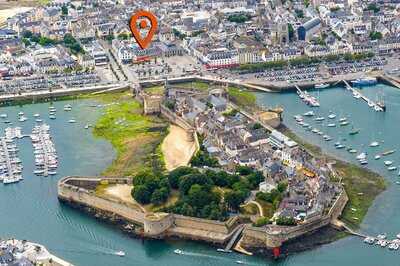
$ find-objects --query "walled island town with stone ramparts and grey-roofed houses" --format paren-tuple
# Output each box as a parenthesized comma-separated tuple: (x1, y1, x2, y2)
(59, 81, 347, 256)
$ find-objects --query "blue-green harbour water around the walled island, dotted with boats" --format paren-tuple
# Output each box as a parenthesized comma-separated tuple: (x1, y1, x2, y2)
(0, 85, 400, 266)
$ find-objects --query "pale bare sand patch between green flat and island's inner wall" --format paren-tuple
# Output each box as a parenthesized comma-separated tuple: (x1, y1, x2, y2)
(161, 125, 195, 171)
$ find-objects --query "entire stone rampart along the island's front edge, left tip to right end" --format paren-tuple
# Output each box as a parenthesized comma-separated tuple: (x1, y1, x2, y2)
(58, 176, 348, 254)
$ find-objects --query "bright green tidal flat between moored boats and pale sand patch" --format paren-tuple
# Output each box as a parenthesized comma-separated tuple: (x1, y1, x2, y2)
(90, 93, 167, 176)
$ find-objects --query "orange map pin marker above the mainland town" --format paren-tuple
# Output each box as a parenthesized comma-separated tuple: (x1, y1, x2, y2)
(129, 10, 158, 49)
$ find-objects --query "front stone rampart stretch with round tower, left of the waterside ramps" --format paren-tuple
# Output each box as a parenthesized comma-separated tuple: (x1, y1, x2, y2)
(58, 177, 239, 243)
